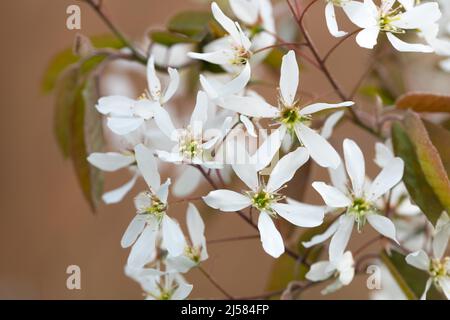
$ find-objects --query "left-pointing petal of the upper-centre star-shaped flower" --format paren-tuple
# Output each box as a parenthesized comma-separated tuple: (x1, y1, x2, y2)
(218, 96, 280, 118)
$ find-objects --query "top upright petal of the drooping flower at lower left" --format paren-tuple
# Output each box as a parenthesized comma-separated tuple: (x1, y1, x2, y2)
(134, 144, 161, 192)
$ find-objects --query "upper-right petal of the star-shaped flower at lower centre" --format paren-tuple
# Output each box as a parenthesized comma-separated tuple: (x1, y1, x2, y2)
(267, 147, 309, 192)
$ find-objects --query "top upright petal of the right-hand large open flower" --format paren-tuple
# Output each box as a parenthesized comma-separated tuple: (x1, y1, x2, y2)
(343, 139, 366, 197)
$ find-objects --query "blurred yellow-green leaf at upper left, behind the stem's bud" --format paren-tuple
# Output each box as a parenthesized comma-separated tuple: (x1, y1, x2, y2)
(41, 35, 123, 93)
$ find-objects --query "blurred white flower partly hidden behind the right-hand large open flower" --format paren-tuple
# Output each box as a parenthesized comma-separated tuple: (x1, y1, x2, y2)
(374, 140, 421, 216)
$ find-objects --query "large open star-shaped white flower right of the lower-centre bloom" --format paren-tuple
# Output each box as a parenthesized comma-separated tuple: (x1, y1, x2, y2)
(310, 139, 404, 260)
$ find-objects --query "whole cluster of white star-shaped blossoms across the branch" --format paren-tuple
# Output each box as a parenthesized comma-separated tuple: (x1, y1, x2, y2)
(88, 0, 450, 300)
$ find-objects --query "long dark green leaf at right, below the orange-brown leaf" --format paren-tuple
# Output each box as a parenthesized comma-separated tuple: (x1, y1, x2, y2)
(392, 122, 444, 224)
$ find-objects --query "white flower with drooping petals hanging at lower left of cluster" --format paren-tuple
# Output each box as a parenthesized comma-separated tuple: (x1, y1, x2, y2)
(121, 144, 185, 268)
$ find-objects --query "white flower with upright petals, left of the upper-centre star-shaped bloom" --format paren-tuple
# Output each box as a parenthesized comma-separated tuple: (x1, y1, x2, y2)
(155, 91, 221, 168)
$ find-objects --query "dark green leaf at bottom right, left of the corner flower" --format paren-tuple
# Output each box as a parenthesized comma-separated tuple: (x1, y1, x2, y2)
(380, 250, 443, 300)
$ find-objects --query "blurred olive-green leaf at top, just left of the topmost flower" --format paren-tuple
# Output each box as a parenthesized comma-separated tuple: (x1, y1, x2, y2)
(167, 11, 212, 40)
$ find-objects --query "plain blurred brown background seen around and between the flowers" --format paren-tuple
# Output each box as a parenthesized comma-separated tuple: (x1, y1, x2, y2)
(0, 0, 384, 299)
